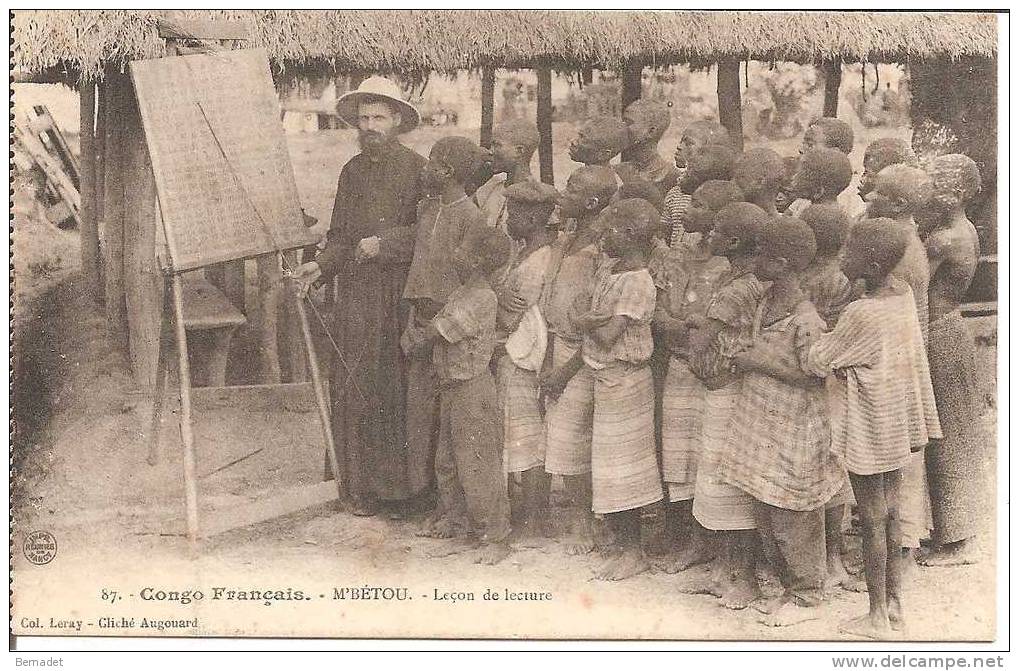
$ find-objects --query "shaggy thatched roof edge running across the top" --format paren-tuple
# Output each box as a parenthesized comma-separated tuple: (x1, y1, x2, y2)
(12, 10, 998, 85)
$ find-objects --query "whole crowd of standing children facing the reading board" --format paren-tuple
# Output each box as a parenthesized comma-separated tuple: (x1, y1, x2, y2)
(324, 100, 979, 637)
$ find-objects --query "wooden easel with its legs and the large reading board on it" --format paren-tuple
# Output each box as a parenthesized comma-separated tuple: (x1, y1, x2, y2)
(130, 41, 342, 543)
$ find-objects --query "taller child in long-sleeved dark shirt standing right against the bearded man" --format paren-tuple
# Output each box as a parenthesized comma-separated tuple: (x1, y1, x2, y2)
(401, 137, 486, 522)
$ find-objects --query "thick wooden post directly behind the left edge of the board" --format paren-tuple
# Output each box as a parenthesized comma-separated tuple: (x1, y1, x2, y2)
(121, 89, 164, 386)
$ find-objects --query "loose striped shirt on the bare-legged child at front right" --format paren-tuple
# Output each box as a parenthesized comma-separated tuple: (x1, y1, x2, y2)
(804, 279, 942, 475)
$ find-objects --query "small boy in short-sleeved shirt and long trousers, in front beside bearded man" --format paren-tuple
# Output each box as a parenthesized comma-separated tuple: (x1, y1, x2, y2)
(405, 227, 511, 564)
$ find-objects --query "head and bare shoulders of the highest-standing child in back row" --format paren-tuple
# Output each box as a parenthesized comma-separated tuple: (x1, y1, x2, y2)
(615, 98, 680, 199)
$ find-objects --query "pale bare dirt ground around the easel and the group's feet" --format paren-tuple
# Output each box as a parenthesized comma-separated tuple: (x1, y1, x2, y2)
(12, 122, 997, 640)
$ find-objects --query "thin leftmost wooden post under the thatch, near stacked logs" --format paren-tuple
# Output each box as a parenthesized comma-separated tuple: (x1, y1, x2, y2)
(78, 82, 102, 302)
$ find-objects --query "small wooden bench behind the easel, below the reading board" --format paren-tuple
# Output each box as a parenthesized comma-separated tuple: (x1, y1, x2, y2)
(183, 273, 248, 386)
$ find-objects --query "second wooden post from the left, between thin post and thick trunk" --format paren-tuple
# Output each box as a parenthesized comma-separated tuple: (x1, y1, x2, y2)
(103, 72, 130, 352)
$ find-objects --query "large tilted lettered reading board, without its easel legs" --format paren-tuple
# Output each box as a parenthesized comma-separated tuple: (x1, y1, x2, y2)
(129, 49, 316, 271)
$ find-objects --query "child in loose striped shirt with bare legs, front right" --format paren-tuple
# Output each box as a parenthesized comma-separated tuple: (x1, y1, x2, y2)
(805, 219, 941, 638)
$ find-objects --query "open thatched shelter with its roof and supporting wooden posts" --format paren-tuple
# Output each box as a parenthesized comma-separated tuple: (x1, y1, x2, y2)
(12, 10, 998, 381)
